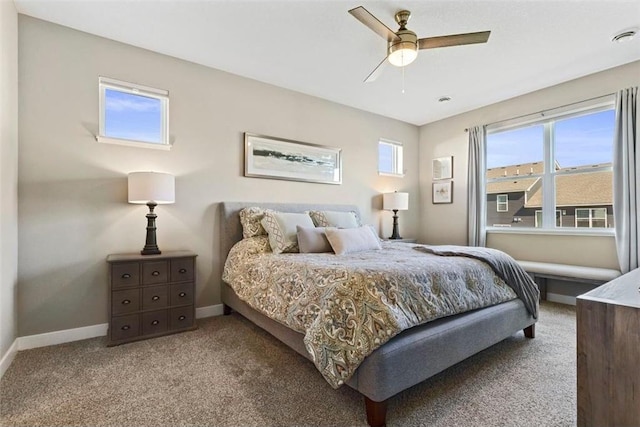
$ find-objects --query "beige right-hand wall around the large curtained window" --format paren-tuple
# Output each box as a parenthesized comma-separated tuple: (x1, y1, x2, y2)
(420, 61, 640, 268)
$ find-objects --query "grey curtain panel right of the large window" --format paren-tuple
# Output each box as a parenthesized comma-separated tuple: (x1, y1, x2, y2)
(613, 86, 640, 274)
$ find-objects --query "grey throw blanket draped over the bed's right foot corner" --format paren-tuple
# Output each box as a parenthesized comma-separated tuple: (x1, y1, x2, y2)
(414, 245, 540, 319)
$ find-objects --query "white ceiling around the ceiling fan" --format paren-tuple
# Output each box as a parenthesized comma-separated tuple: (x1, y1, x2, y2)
(11, 0, 640, 125)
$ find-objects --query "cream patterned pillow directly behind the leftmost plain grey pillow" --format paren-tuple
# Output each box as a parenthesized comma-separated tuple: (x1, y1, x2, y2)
(260, 209, 313, 254)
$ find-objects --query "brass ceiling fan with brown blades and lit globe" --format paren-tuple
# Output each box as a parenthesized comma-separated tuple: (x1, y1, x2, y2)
(349, 6, 491, 83)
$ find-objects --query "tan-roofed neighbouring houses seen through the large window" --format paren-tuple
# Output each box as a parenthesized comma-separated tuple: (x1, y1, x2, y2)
(487, 161, 613, 228)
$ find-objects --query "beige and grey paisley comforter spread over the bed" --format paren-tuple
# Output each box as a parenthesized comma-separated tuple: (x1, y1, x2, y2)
(222, 236, 535, 388)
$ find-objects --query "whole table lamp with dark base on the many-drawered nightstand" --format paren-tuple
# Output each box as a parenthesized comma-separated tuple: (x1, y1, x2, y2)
(127, 172, 176, 255)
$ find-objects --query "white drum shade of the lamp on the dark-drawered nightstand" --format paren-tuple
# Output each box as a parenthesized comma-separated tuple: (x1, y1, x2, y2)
(128, 172, 176, 205)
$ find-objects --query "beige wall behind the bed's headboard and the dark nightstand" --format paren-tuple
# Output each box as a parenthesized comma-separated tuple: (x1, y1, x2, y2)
(18, 15, 419, 336)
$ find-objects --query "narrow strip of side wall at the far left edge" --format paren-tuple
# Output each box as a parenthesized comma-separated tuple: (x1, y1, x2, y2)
(0, 1, 18, 359)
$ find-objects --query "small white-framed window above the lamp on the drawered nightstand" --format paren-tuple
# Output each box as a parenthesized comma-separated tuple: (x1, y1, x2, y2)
(96, 77, 170, 149)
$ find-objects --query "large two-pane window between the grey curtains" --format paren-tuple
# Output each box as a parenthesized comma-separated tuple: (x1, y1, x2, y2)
(486, 99, 615, 229)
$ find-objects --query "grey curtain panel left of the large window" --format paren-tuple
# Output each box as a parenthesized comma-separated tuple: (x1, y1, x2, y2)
(467, 126, 487, 246)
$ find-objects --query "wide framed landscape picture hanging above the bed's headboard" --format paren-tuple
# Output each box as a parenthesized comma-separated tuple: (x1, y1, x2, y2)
(244, 132, 342, 184)
